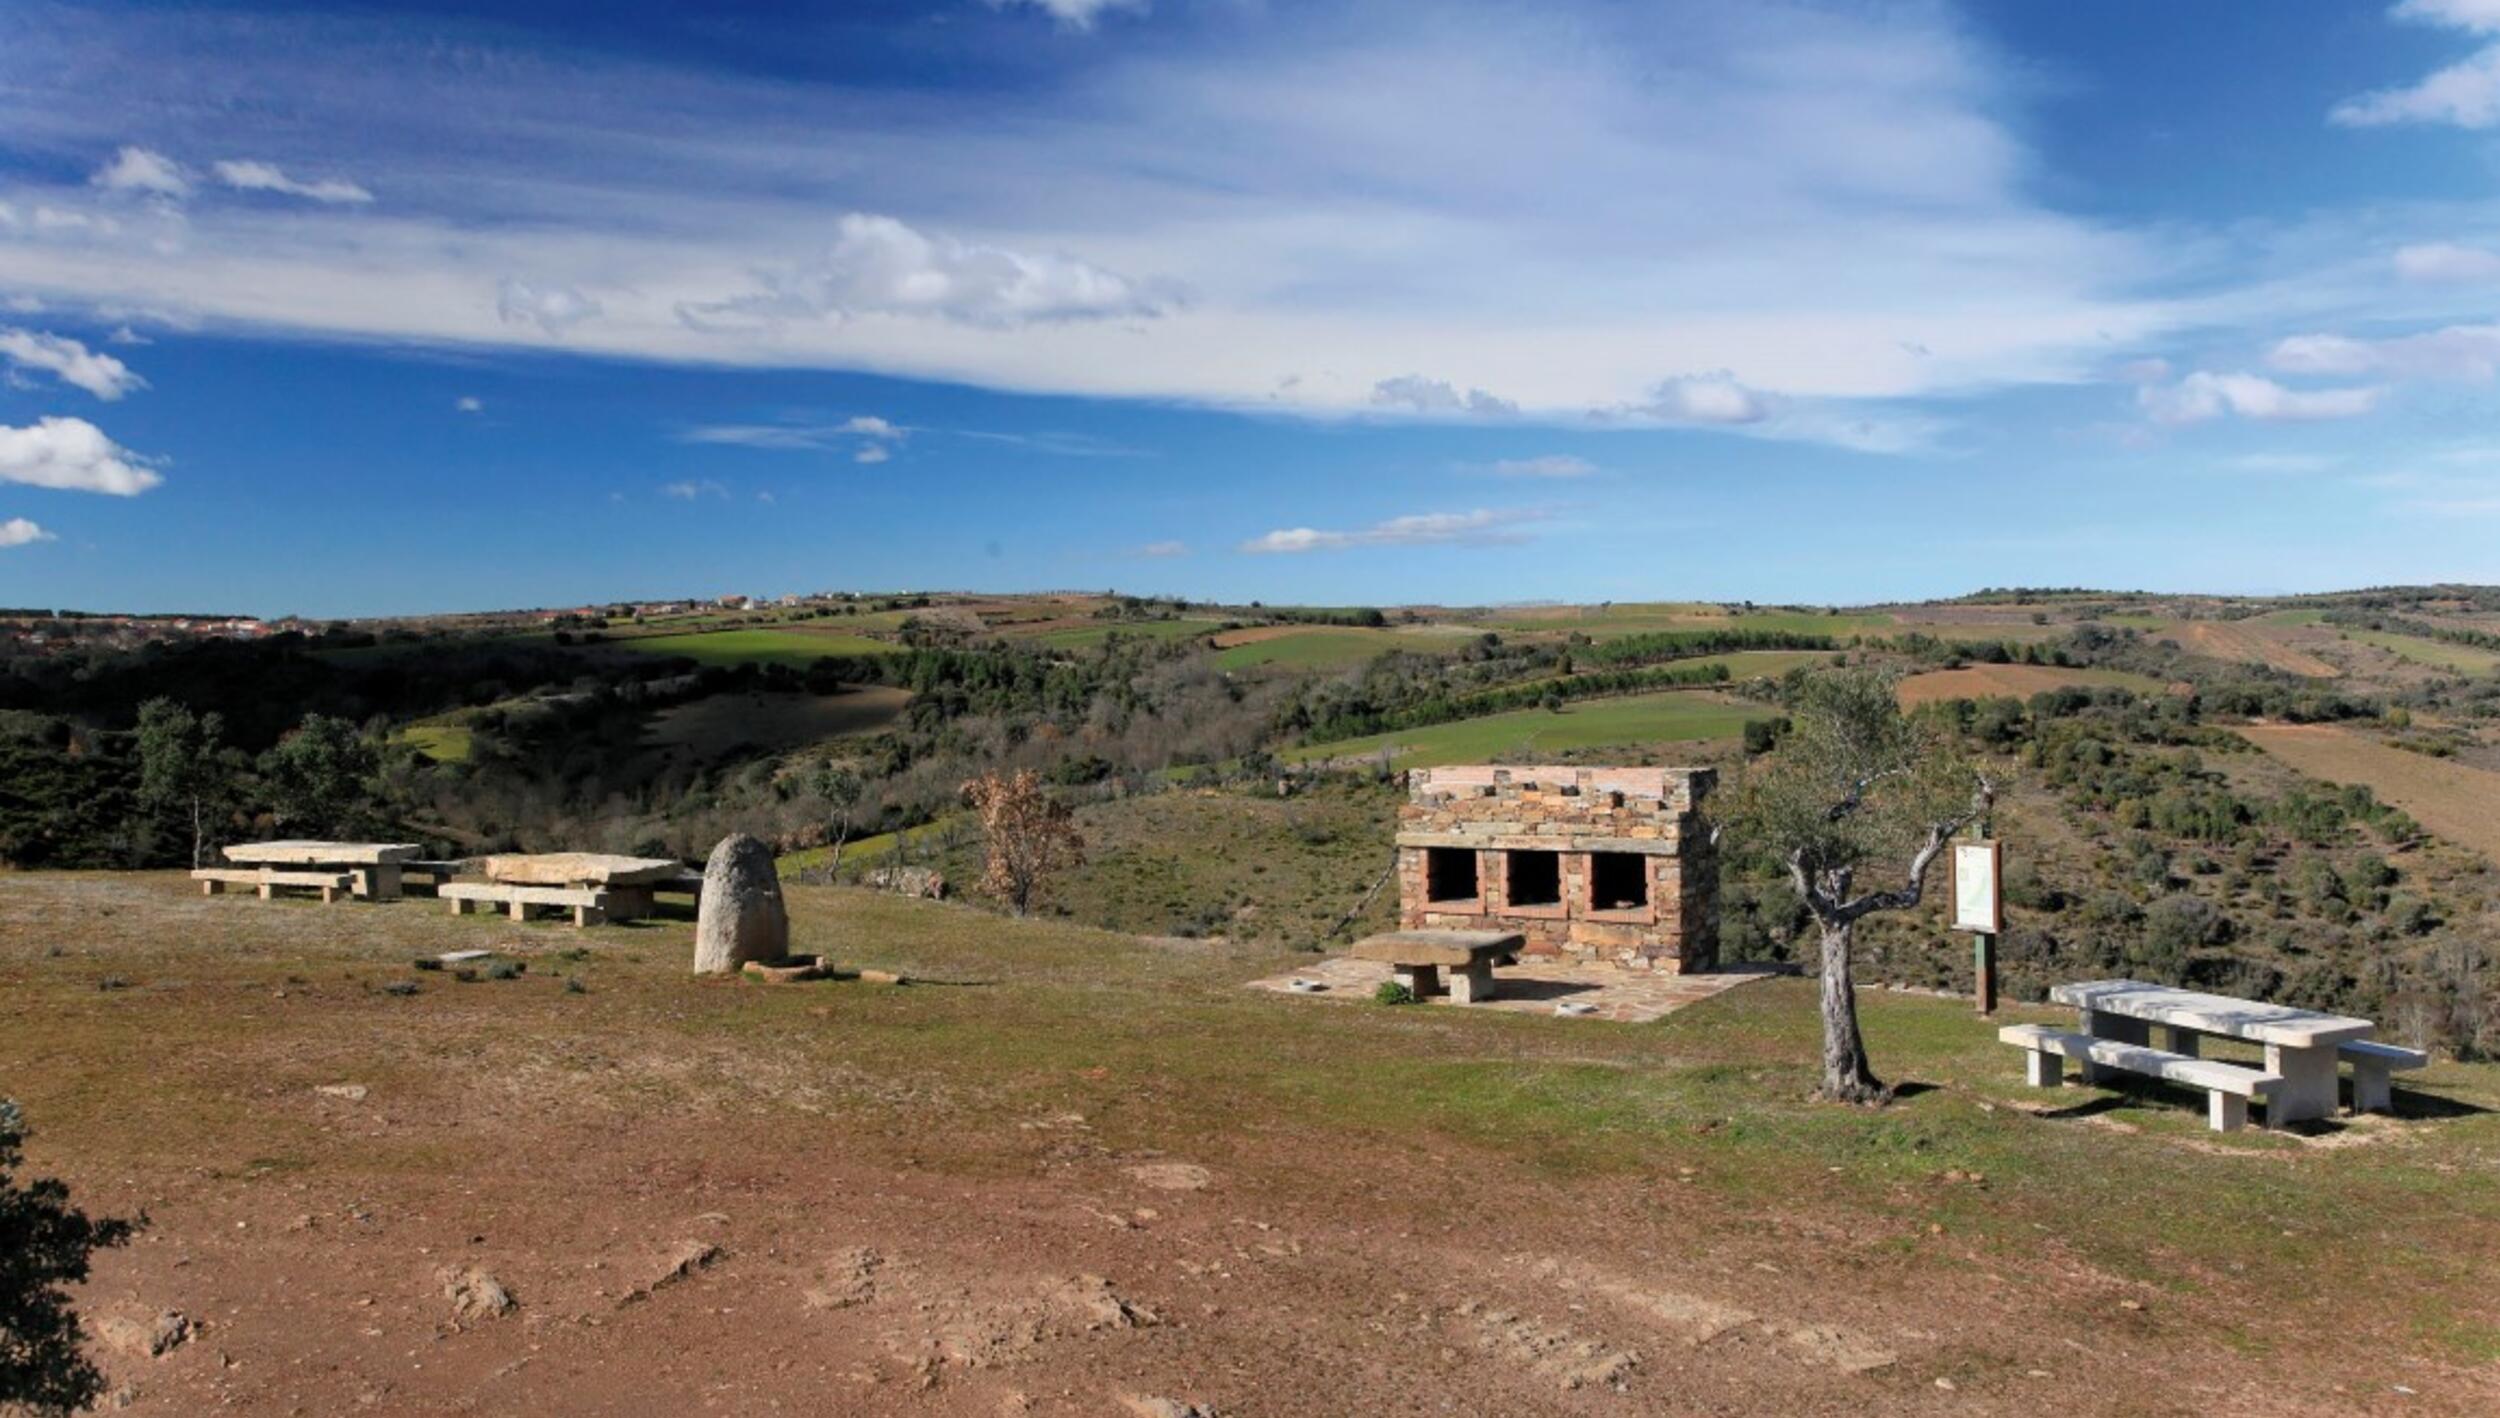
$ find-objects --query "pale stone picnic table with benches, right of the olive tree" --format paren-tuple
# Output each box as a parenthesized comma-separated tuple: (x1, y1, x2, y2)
(2005, 980, 2425, 1130)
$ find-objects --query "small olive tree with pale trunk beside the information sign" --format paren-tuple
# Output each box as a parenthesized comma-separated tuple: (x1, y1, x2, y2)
(1738, 670, 1995, 1103)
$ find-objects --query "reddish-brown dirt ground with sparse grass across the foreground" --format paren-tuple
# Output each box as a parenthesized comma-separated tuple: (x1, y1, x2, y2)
(0, 875, 2500, 1418)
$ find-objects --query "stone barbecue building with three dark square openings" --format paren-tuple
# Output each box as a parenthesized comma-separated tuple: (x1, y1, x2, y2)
(1398, 765, 1718, 973)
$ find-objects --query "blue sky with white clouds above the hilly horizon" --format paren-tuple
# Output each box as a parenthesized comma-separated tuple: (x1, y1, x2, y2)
(0, 0, 2500, 615)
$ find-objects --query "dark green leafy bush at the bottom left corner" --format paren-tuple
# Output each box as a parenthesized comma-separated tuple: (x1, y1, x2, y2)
(0, 1098, 145, 1413)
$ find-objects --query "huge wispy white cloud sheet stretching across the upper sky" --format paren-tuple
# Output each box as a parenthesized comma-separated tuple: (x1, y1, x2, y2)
(0, 3, 2203, 445)
